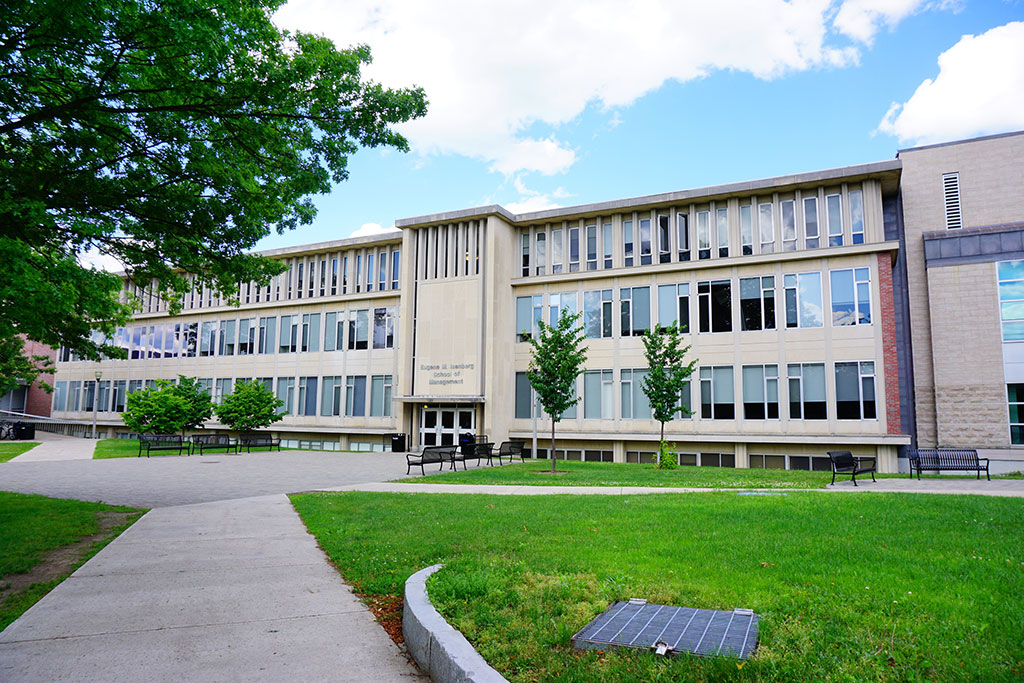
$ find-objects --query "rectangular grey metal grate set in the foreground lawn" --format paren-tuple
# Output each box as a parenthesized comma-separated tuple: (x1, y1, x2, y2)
(572, 598, 760, 659)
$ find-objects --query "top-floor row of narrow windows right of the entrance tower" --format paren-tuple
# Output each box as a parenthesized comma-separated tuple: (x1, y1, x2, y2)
(517, 189, 864, 276)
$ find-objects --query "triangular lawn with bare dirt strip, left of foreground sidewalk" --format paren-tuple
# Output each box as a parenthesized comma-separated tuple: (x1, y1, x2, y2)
(0, 492, 144, 630)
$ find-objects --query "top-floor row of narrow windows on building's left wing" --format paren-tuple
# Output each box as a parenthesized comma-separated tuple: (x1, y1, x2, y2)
(124, 245, 399, 313)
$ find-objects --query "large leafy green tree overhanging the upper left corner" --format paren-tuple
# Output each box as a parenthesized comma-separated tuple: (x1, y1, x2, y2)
(0, 0, 426, 393)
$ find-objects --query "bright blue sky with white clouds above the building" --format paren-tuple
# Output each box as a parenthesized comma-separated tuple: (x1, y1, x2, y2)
(258, 0, 1024, 249)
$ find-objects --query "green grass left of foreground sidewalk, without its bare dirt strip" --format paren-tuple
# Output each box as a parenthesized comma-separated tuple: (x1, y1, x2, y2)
(0, 492, 144, 630)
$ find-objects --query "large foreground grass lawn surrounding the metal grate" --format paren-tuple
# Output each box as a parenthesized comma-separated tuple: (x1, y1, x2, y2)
(292, 492, 1024, 682)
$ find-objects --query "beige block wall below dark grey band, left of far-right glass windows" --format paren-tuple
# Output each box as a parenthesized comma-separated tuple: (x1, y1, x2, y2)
(928, 263, 1010, 449)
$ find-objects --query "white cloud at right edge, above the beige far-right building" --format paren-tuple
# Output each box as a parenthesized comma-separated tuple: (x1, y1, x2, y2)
(878, 22, 1024, 144)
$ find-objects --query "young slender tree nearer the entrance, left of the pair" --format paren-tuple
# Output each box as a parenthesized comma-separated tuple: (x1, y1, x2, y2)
(526, 313, 587, 474)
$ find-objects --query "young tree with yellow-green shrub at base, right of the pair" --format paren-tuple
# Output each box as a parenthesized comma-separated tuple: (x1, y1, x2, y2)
(640, 325, 697, 451)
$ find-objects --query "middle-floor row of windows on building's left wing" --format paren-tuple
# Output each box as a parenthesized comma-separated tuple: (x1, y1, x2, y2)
(58, 306, 397, 361)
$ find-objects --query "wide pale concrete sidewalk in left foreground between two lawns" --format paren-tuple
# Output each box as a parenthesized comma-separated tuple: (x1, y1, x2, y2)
(0, 495, 425, 681)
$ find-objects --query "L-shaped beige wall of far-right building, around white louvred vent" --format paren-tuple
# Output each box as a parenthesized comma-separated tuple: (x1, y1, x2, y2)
(899, 134, 1024, 447)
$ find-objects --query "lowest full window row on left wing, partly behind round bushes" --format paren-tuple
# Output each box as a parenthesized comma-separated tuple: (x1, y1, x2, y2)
(52, 375, 393, 418)
